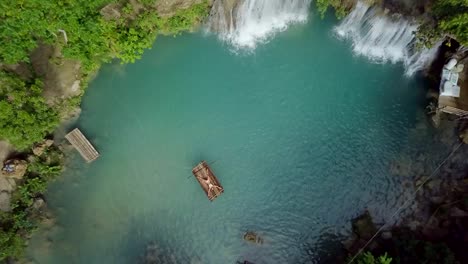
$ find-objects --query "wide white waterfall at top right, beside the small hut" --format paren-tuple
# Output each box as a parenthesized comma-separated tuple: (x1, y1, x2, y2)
(335, 1, 439, 76)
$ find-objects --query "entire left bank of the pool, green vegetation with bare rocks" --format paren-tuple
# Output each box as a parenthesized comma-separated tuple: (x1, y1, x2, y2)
(0, 0, 210, 262)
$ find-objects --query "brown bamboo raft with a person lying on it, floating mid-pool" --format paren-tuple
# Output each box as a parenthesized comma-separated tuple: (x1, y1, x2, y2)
(192, 161, 224, 201)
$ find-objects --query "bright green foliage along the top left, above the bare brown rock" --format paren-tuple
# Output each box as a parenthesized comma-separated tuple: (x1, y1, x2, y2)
(0, 0, 209, 68)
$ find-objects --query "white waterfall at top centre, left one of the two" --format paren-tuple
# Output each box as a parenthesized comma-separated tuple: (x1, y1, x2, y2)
(208, 0, 311, 49)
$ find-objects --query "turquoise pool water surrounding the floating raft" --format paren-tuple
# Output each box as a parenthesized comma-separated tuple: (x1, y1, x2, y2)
(28, 13, 450, 264)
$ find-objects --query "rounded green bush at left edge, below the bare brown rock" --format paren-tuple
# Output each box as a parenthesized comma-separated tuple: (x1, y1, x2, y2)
(0, 71, 58, 149)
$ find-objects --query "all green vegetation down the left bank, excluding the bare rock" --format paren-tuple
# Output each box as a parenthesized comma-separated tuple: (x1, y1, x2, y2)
(0, 0, 209, 263)
